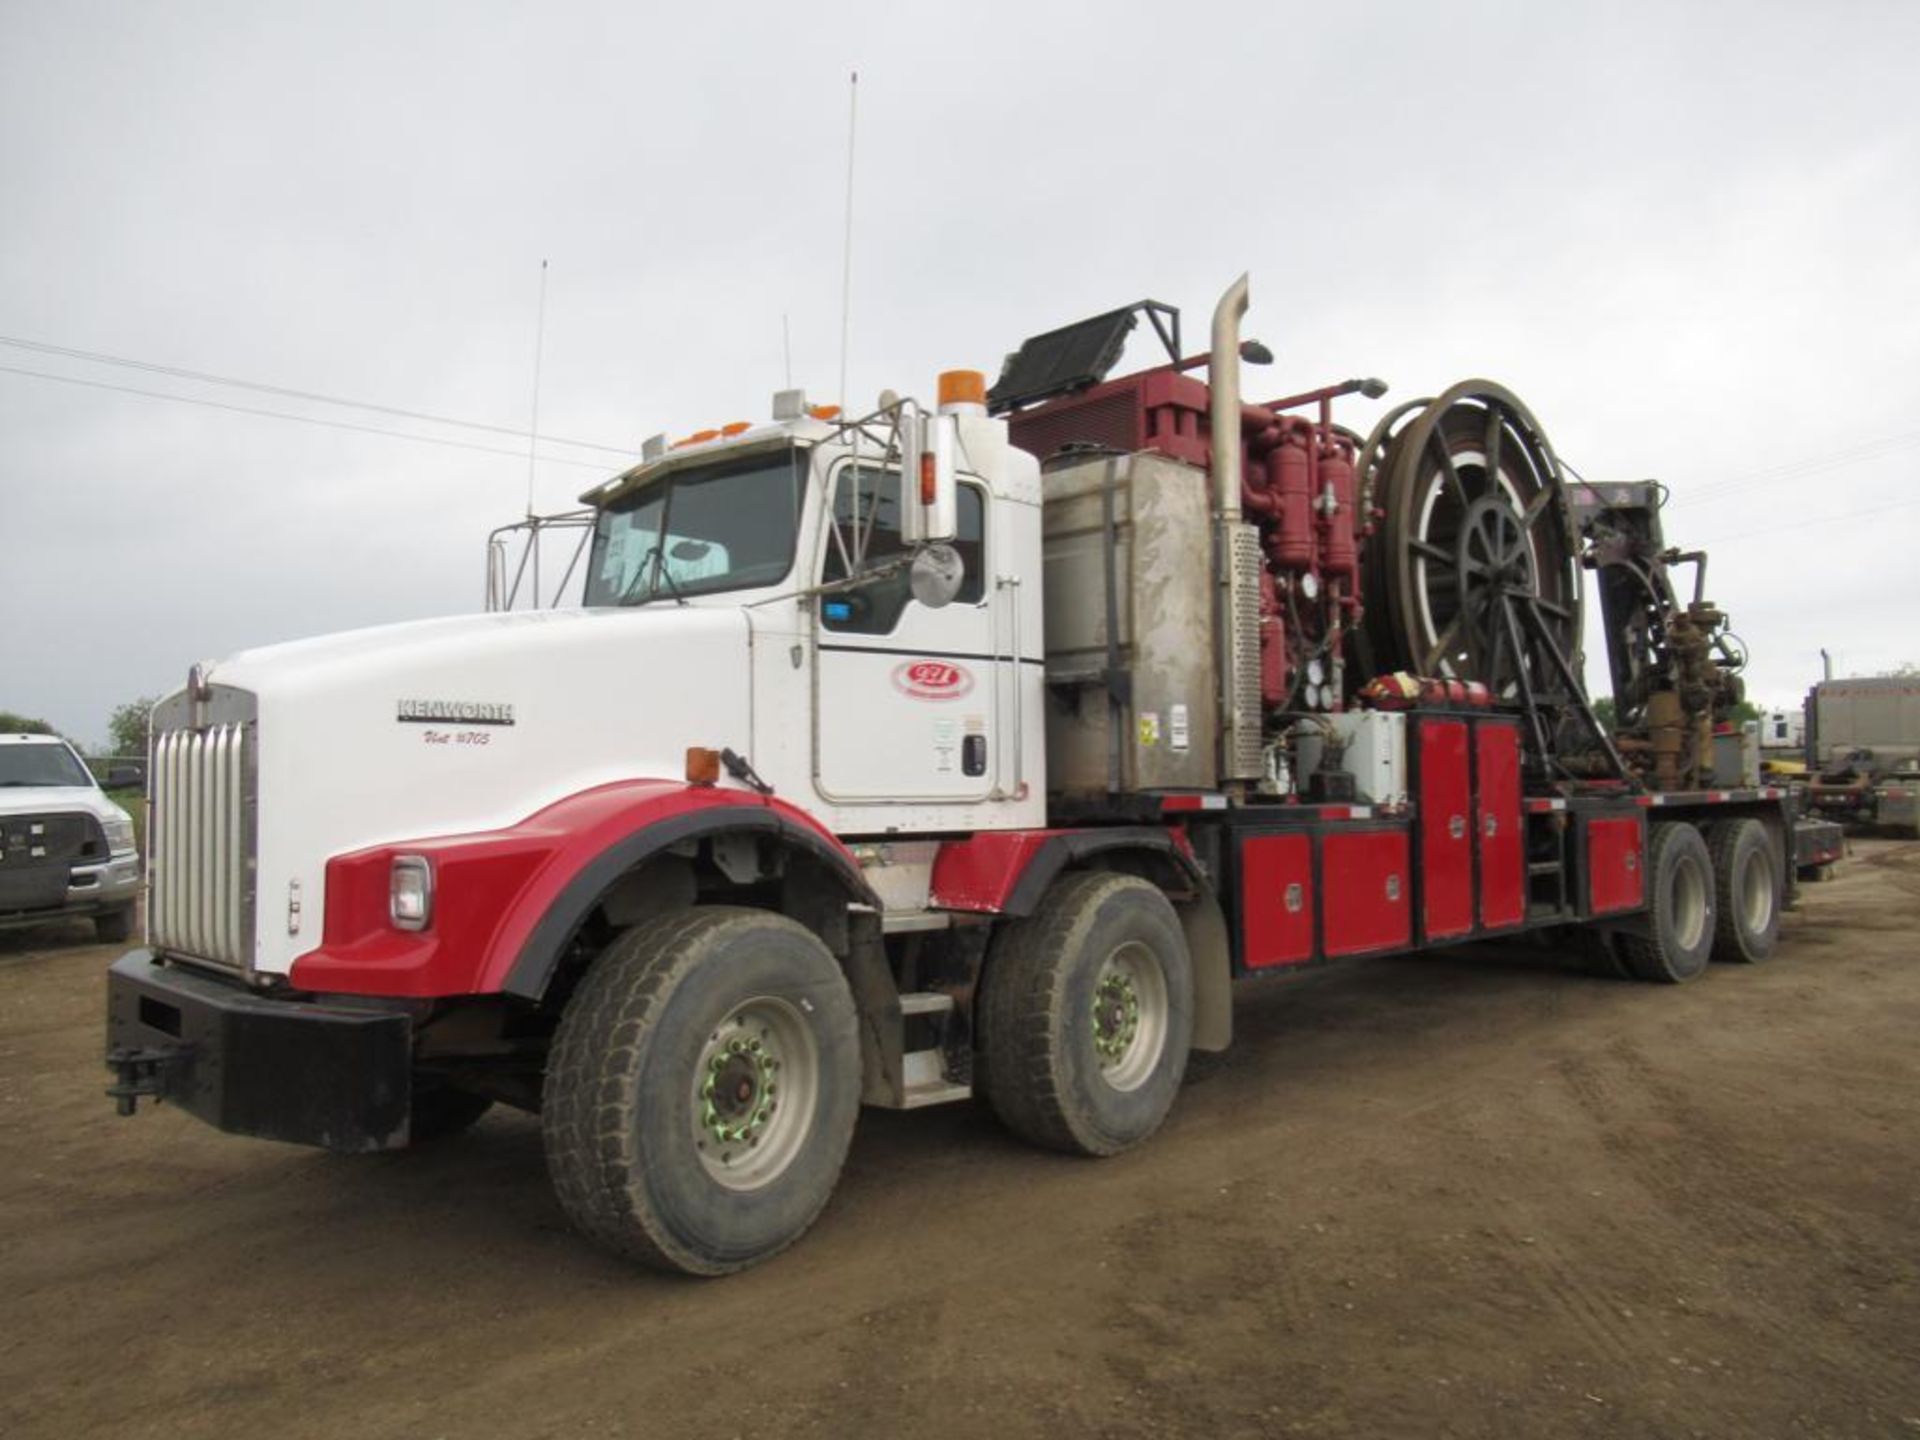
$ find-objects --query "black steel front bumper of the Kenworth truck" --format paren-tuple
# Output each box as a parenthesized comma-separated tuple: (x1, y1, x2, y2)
(108, 950, 413, 1152)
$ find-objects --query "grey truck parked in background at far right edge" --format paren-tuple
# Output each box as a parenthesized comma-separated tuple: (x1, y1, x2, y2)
(1807, 676, 1920, 835)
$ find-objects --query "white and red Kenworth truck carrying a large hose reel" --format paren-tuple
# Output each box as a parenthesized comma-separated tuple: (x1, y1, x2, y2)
(108, 276, 1827, 1275)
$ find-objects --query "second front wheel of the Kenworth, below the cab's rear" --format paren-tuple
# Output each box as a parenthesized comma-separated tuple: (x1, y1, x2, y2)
(979, 874, 1194, 1156)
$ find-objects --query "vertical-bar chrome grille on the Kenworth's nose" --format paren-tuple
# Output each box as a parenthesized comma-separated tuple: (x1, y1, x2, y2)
(146, 707, 255, 970)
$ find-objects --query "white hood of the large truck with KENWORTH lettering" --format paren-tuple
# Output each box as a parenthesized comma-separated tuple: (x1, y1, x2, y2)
(174, 603, 751, 972)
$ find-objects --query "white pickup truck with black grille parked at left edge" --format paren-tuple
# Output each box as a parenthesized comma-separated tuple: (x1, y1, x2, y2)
(0, 735, 140, 943)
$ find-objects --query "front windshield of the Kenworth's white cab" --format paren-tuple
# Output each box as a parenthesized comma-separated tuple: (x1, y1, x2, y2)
(586, 445, 806, 605)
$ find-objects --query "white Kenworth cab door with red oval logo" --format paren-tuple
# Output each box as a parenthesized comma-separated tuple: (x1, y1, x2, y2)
(812, 463, 1016, 804)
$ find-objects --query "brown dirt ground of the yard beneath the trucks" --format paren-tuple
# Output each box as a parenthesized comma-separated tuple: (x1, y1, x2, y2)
(0, 841, 1920, 1440)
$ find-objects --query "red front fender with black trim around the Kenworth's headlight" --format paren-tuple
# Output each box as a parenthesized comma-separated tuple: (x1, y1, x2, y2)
(292, 780, 874, 998)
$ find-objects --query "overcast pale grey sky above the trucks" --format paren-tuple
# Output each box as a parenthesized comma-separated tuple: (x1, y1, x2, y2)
(0, 0, 1920, 741)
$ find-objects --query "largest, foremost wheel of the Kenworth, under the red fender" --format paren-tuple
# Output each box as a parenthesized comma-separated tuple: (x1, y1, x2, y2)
(541, 906, 860, 1275)
